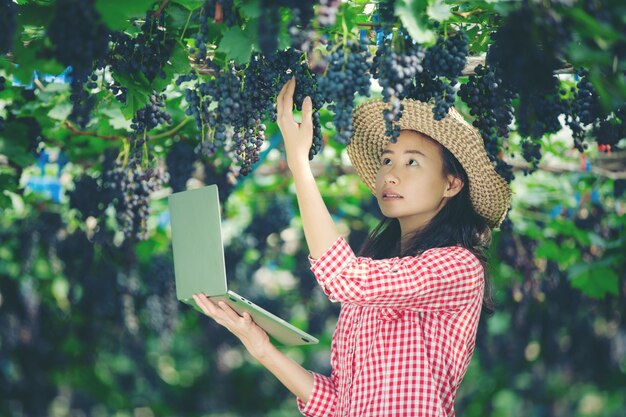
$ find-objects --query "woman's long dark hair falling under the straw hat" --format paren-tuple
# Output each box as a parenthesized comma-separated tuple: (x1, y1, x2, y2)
(359, 135, 493, 315)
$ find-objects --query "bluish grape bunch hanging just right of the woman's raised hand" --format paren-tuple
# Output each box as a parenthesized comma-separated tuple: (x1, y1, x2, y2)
(318, 40, 371, 144)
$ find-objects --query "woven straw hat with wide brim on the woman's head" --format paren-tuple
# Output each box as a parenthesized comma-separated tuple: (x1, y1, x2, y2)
(347, 99, 511, 228)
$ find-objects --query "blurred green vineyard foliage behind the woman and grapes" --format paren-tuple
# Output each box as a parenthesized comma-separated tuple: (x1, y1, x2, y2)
(0, 0, 626, 417)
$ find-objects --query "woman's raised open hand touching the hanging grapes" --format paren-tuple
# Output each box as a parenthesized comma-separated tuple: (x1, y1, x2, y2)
(276, 77, 313, 171)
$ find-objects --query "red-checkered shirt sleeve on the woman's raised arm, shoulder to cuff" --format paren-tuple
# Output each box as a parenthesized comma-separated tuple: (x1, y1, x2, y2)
(309, 237, 484, 311)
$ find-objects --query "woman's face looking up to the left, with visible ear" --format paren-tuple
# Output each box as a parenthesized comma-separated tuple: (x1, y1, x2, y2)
(376, 130, 463, 235)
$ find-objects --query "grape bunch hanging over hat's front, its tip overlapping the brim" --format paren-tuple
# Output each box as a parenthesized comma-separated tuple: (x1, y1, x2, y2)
(371, 35, 425, 142)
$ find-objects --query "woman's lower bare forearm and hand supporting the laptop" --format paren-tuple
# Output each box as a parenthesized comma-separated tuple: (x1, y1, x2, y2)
(193, 294, 314, 402)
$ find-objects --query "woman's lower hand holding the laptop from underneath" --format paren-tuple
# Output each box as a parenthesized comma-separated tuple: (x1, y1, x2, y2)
(193, 294, 272, 360)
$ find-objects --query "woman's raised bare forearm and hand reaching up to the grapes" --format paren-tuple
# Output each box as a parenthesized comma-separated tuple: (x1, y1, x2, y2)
(276, 77, 340, 258)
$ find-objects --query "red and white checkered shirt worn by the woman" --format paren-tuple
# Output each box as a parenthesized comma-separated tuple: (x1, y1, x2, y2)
(297, 237, 484, 417)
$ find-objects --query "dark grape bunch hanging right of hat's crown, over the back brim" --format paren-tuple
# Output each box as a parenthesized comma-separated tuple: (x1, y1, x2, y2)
(458, 65, 514, 182)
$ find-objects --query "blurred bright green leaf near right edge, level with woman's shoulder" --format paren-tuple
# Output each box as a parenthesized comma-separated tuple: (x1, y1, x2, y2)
(568, 263, 619, 298)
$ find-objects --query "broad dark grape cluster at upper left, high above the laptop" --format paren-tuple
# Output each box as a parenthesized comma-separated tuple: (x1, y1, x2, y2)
(107, 12, 176, 82)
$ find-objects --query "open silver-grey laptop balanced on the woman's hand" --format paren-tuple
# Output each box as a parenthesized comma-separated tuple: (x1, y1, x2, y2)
(168, 185, 319, 345)
